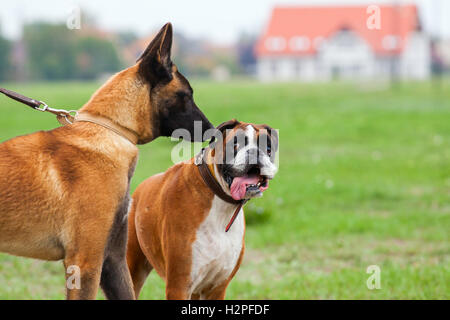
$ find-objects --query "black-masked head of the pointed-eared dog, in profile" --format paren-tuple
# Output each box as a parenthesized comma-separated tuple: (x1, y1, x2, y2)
(138, 23, 214, 141)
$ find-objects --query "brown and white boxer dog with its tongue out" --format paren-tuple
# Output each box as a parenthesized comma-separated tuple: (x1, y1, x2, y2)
(127, 120, 278, 299)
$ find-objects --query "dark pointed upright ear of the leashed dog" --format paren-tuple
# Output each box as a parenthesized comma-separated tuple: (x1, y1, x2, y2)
(137, 22, 173, 87)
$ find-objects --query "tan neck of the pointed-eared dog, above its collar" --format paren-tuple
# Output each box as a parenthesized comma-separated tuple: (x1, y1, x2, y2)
(80, 65, 158, 143)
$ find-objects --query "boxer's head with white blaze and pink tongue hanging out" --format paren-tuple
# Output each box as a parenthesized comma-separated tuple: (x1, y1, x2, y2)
(211, 119, 278, 200)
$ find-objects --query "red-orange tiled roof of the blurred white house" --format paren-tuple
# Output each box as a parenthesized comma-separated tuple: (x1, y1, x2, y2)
(255, 5, 419, 56)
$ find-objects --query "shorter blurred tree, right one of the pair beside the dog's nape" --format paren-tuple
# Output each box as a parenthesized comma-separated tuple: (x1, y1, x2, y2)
(76, 36, 122, 80)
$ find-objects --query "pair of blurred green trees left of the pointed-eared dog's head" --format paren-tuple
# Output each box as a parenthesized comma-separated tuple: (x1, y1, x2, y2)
(23, 22, 121, 80)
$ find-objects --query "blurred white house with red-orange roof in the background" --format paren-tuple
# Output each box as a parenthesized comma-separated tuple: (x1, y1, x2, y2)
(255, 5, 431, 81)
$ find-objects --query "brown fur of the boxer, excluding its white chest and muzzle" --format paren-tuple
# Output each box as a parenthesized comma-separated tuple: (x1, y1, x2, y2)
(127, 120, 272, 299)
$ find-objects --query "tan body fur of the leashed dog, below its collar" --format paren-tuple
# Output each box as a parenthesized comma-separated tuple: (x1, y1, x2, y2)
(0, 75, 141, 299)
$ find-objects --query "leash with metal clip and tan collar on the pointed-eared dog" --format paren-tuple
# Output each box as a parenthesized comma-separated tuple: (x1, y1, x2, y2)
(0, 88, 139, 144)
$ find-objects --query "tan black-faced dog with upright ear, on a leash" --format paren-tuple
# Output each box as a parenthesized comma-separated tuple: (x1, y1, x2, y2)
(0, 24, 212, 299)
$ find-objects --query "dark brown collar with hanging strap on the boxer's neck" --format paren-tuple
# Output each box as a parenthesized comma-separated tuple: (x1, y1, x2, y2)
(195, 148, 248, 232)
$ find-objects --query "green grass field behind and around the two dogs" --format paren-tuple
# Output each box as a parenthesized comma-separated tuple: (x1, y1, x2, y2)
(0, 81, 450, 299)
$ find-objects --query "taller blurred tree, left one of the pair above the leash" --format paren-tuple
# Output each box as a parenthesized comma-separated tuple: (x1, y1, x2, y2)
(23, 22, 76, 80)
